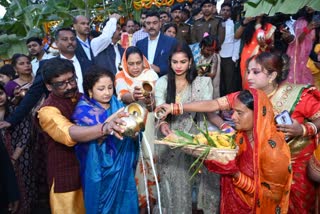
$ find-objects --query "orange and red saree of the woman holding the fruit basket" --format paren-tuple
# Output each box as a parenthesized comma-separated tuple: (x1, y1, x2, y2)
(205, 89, 292, 214)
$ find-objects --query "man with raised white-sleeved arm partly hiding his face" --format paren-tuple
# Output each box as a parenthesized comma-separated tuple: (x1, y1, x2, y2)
(91, 13, 124, 75)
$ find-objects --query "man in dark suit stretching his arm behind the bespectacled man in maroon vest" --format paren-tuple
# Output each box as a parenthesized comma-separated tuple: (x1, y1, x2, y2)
(0, 28, 92, 128)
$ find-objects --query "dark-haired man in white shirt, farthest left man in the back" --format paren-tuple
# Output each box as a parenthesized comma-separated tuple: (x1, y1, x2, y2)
(26, 37, 54, 76)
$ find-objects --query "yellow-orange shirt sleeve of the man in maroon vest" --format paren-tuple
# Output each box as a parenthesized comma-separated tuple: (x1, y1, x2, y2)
(38, 106, 77, 146)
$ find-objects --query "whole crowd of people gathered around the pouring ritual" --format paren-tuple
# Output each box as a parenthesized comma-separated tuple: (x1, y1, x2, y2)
(0, 0, 320, 214)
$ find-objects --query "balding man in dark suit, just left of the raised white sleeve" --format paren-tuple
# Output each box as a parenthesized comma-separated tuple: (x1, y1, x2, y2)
(73, 15, 93, 61)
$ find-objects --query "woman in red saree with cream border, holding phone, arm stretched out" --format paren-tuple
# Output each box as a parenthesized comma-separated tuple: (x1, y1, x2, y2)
(158, 52, 320, 214)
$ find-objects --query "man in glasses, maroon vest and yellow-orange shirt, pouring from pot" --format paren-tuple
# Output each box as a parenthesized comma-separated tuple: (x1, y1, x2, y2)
(38, 58, 128, 214)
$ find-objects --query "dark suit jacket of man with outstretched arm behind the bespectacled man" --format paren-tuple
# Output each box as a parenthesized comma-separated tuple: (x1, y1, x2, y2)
(6, 53, 93, 126)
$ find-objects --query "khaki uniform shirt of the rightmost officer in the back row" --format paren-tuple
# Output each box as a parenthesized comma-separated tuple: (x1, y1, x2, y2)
(191, 16, 226, 47)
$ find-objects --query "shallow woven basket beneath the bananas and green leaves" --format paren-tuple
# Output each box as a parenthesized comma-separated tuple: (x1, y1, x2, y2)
(155, 140, 238, 164)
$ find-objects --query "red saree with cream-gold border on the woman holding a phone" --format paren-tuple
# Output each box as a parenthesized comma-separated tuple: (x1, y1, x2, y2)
(271, 84, 320, 214)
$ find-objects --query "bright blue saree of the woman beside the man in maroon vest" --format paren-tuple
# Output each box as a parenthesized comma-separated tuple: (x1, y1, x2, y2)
(73, 96, 139, 214)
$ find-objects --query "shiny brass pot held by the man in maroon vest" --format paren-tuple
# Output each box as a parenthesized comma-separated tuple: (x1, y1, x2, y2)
(121, 103, 147, 137)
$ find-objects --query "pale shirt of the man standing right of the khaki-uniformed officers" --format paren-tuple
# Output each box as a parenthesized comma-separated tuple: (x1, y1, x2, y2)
(220, 18, 240, 62)
